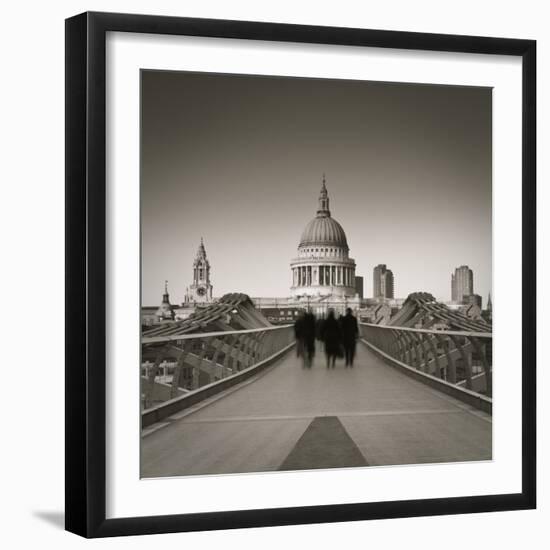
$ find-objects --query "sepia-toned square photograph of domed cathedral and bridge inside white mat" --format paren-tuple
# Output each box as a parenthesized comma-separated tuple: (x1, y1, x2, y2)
(140, 70, 494, 478)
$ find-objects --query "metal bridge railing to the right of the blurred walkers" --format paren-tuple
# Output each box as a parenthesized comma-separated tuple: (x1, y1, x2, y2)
(359, 323, 493, 397)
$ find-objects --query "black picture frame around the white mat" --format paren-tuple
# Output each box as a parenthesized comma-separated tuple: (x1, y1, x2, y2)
(65, 13, 536, 537)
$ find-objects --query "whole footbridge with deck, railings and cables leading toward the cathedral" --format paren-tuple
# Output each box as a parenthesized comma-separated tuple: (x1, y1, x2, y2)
(141, 293, 492, 477)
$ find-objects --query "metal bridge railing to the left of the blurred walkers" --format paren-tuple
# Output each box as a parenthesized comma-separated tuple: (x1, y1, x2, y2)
(141, 325, 295, 411)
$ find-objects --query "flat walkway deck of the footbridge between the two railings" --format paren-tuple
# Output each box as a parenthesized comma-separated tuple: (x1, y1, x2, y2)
(141, 344, 492, 477)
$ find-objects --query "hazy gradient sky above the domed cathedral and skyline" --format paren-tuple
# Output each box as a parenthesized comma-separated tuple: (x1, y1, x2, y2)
(141, 71, 492, 305)
